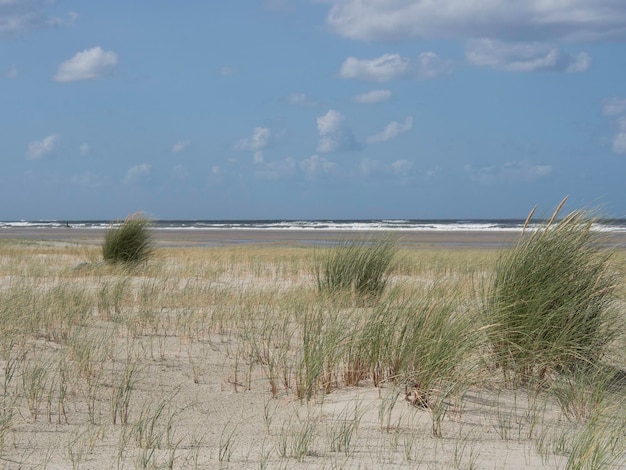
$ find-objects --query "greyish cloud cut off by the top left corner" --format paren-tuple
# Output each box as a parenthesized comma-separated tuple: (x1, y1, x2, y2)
(0, 0, 78, 35)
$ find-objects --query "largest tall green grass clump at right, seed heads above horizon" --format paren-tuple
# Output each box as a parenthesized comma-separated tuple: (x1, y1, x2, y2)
(486, 200, 619, 383)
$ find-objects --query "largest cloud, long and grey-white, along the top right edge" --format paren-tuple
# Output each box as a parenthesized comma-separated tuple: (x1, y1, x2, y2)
(327, 0, 626, 42)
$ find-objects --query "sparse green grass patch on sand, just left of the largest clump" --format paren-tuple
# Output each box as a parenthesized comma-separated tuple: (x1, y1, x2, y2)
(349, 285, 481, 437)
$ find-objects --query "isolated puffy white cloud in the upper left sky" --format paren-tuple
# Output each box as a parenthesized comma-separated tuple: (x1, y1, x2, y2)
(54, 47, 117, 82)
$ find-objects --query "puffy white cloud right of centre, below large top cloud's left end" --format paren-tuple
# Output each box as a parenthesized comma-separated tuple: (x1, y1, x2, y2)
(339, 54, 410, 82)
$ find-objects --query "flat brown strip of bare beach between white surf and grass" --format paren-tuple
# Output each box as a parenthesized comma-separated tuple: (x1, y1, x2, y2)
(0, 227, 626, 249)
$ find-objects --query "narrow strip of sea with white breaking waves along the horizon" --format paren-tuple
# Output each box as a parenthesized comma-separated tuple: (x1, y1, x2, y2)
(0, 219, 626, 232)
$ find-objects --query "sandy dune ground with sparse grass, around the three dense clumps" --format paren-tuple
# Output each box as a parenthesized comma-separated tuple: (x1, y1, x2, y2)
(0, 232, 626, 468)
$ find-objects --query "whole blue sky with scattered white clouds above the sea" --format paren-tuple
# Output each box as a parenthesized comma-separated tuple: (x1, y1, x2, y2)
(0, 0, 626, 220)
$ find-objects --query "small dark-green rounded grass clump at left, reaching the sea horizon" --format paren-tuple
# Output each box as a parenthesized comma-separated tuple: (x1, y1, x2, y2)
(102, 213, 154, 264)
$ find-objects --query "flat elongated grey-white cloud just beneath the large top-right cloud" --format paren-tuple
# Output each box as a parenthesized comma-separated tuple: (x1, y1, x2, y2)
(465, 39, 591, 72)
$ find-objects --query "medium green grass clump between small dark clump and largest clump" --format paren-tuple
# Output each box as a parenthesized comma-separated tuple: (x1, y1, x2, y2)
(315, 236, 398, 298)
